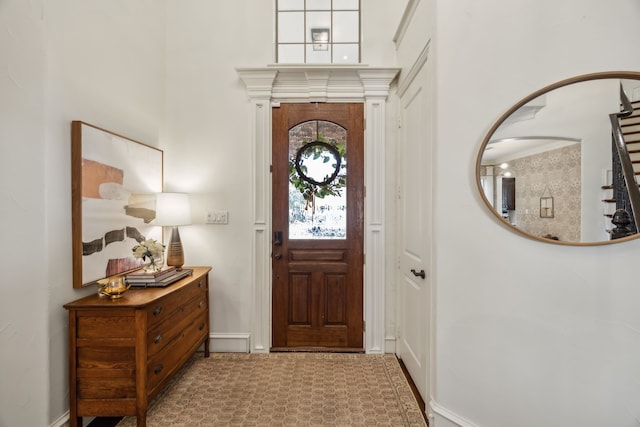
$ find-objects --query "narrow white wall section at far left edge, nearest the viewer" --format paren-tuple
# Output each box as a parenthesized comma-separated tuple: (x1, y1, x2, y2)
(0, 0, 49, 426)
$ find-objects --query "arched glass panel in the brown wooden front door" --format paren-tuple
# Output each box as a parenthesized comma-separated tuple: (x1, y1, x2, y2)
(289, 120, 347, 239)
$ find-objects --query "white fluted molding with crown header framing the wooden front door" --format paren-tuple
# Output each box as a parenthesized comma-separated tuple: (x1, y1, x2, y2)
(236, 65, 399, 354)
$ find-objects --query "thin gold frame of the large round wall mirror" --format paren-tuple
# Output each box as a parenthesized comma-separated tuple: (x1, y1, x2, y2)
(476, 71, 640, 246)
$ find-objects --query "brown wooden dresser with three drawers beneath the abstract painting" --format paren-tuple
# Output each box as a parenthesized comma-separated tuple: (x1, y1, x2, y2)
(64, 267, 211, 427)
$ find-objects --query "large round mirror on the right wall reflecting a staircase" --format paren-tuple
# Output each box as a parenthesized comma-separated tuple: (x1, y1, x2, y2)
(476, 72, 640, 245)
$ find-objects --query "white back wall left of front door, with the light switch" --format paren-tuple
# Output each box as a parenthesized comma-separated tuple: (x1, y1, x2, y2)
(162, 0, 273, 340)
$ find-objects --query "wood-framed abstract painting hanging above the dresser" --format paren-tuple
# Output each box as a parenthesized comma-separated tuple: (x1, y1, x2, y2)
(71, 121, 164, 288)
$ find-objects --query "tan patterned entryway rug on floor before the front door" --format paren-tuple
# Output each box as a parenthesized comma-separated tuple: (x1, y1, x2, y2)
(118, 353, 426, 427)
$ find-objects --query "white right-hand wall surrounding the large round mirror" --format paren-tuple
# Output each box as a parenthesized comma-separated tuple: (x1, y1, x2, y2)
(432, 0, 640, 427)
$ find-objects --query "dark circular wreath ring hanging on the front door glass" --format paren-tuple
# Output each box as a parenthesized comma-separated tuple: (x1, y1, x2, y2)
(296, 141, 341, 185)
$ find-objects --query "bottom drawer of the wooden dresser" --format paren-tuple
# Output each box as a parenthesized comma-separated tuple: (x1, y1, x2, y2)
(147, 312, 208, 394)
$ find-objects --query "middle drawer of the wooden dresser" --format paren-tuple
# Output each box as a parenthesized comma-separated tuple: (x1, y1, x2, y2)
(147, 292, 207, 357)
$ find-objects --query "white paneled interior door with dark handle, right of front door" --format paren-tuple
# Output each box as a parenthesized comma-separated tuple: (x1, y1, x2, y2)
(397, 62, 432, 402)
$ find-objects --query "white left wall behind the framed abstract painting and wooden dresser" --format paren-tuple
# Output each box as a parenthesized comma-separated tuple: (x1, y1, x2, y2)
(0, 0, 164, 426)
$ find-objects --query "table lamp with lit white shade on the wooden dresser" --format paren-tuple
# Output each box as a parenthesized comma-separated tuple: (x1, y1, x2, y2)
(154, 193, 191, 270)
